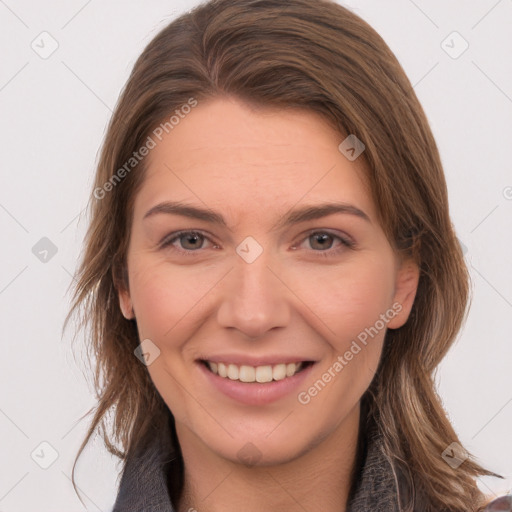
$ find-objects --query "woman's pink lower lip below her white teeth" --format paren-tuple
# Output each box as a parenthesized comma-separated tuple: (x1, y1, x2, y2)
(197, 362, 315, 405)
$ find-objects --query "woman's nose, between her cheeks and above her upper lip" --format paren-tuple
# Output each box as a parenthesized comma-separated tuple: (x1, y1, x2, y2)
(217, 251, 291, 339)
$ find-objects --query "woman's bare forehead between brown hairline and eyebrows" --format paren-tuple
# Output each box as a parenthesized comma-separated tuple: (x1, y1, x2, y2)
(130, 98, 375, 222)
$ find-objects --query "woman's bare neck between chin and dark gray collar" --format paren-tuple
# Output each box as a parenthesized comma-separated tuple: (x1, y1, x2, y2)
(176, 404, 360, 512)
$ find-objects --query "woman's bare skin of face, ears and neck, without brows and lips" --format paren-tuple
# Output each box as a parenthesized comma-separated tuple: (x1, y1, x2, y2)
(119, 97, 419, 512)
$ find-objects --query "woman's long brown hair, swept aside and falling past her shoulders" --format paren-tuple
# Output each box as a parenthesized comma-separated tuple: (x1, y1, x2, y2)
(65, 0, 496, 512)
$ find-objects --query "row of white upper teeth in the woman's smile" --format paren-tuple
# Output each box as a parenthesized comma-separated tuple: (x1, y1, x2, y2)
(207, 361, 303, 383)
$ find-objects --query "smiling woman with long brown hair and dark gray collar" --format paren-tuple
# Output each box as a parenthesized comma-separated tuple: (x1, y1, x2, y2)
(66, 0, 512, 512)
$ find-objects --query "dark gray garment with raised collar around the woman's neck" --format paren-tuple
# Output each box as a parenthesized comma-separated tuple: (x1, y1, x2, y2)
(112, 418, 512, 512)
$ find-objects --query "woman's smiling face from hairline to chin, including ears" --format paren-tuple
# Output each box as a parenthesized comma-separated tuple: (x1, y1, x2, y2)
(119, 98, 418, 464)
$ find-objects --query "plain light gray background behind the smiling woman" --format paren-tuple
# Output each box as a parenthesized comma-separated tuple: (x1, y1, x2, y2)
(0, 0, 512, 512)
